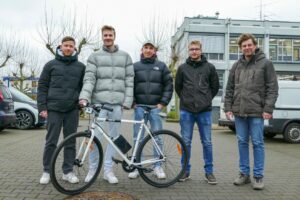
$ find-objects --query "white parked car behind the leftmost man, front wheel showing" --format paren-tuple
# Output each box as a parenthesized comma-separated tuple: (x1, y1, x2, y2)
(9, 87, 46, 129)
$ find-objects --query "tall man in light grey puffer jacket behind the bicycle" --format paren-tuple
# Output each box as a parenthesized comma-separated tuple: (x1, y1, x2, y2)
(79, 26, 134, 184)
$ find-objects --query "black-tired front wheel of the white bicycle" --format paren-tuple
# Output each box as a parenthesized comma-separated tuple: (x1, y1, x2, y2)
(50, 131, 103, 195)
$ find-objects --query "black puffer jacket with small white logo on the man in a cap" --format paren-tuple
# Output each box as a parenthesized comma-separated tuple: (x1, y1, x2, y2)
(133, 57, 173, 105)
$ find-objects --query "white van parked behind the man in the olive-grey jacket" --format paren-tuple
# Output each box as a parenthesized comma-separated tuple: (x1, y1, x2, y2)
(219, 80, 300, 143)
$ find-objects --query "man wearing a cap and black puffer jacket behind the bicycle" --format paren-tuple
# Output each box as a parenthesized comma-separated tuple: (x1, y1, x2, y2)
(128, 41, 173, 179)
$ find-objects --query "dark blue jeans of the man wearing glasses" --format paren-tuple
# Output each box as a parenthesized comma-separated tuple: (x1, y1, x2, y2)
(180, 110, 213, 174)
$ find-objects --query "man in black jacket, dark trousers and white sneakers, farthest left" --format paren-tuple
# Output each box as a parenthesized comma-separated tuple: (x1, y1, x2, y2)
(37, 36, 85, 184)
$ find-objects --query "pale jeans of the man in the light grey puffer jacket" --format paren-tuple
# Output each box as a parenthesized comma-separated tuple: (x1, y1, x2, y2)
(89, 104, 122, 173)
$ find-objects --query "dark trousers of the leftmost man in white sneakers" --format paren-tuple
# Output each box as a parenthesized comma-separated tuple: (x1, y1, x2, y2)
(43, 109, 79, 174)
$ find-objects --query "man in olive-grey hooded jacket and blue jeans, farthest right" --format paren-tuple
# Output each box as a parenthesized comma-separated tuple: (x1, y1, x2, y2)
(225, 34, 278, 190)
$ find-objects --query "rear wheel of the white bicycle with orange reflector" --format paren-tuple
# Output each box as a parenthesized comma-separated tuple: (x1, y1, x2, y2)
(137, 130, 187, 188)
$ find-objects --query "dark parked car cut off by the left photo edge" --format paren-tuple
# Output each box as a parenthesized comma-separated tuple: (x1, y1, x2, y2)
(0, 84, 16, 131)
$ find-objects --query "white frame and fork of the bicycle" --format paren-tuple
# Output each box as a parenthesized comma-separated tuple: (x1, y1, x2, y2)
(76, 108, 166, 166)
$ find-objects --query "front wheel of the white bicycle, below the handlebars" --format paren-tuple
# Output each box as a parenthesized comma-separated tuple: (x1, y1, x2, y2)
(50, 131, 103, 195)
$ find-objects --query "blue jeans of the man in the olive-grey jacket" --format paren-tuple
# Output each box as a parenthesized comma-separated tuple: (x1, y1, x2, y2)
(235, 116, 265, 177)
